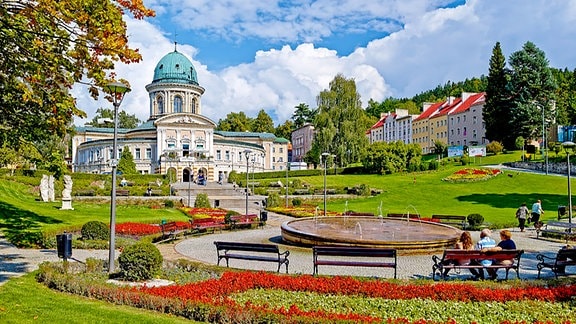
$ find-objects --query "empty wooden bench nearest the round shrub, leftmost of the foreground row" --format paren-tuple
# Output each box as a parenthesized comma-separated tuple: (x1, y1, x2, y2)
(214, 241, 290, 273)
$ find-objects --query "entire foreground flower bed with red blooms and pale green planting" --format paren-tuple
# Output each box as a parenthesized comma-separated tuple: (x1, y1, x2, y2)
(37, 263, 576, 324)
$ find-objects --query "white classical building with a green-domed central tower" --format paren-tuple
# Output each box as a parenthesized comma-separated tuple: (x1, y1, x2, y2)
(72, 50, 289, 182)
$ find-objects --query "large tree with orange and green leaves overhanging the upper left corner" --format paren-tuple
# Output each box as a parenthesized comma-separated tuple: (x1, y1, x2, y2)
(0, 0, 154, 149)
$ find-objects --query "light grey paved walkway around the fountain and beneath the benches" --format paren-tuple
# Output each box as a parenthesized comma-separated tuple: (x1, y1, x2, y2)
(0, 213, 564, 285)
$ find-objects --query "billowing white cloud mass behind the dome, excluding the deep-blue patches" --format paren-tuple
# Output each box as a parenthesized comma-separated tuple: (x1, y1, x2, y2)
(74, 0, 576, 125)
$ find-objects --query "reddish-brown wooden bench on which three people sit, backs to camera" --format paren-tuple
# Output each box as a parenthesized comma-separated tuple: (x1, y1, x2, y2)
(432, 249, 524, 280)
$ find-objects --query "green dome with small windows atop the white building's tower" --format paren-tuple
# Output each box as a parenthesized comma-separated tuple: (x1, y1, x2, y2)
(152, 51, 198, 85)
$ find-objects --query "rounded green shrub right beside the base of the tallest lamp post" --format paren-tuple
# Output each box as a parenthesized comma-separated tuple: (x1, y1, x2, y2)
(118, 242, 163, 281)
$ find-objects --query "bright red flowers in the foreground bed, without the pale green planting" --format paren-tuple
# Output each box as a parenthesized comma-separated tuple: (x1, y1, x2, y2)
(133, 272, 576, 322)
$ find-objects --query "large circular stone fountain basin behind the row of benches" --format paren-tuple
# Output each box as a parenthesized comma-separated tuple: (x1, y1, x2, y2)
(281, 216, 461, 250)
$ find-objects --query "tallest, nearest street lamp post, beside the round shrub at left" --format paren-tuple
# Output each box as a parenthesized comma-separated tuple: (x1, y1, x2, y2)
(104, 82, 130, 273)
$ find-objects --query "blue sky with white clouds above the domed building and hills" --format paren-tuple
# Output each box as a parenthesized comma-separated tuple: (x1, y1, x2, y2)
(73, 0, 576, 126)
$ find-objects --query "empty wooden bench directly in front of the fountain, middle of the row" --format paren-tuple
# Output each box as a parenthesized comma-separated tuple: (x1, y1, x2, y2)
(312, 246, 397, 279)
